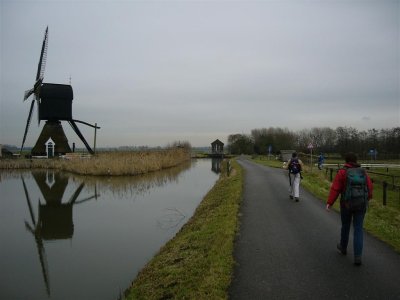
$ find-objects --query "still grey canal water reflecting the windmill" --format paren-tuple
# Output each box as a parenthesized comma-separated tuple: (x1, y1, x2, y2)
(0, 159, 218, 300)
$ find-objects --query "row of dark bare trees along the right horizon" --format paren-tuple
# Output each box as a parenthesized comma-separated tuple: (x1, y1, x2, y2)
(227, 127, 400, 159)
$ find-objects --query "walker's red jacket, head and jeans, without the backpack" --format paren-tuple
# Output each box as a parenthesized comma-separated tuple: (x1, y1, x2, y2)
(326, 153, 373, 265)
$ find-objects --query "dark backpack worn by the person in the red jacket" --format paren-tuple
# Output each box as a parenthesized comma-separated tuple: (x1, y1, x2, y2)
(342, 167, 368, 211)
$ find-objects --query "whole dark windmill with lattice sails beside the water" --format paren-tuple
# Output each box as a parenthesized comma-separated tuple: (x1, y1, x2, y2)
(21, 27, 100, 156)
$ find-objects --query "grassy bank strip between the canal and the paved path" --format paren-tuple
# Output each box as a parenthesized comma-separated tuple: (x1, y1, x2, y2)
(124, 162, 243, 299)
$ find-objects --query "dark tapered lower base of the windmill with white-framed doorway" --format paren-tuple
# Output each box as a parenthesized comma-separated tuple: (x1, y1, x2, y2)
(31, 121, 72, 156)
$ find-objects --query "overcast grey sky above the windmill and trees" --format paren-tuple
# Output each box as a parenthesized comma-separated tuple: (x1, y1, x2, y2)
(0, 0, 400, 147)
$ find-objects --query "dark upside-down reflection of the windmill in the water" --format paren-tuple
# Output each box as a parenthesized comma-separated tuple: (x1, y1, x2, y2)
(21, 171, 100, 295)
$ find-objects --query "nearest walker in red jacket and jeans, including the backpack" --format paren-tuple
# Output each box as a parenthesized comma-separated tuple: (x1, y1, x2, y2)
(326, 153, 373, 265)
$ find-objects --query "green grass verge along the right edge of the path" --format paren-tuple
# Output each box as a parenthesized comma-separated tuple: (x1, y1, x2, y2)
(254, 157, 400, 252)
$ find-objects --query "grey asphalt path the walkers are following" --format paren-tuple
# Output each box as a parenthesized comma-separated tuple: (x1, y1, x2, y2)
(229, 158, 400, 300)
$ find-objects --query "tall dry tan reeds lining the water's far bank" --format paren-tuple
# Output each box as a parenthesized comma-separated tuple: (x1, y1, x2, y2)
(0, 147, 190, 175)
